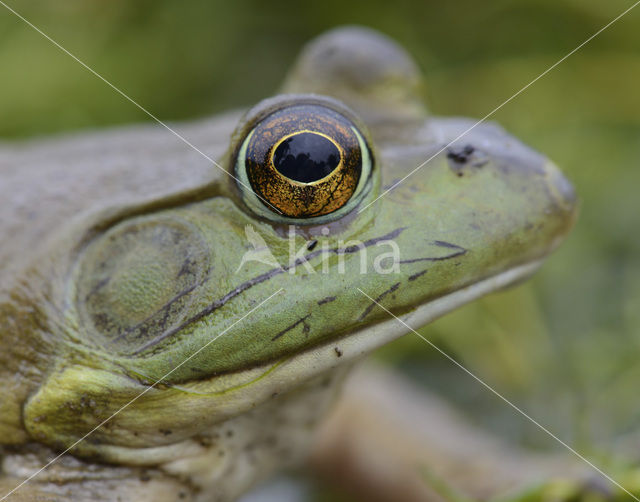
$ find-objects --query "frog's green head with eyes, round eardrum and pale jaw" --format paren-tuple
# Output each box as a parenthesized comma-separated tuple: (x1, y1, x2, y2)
(6, 28, 575, 460)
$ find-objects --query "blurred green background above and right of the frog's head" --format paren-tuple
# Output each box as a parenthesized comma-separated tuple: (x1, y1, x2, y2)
(0, 0, 640, 498)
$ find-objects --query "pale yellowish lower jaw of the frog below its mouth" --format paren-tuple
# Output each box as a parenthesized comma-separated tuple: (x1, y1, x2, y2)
(24, 260, 544, 466)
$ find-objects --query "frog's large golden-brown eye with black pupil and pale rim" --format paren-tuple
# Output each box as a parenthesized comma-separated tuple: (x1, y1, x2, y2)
(235, 103, 372, 223)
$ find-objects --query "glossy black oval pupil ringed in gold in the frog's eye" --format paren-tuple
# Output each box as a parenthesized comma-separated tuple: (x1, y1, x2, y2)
(273, 132, 340, 183)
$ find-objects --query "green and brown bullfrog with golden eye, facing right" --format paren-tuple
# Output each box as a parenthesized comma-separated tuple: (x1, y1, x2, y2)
(0, 27, 576, 501)
